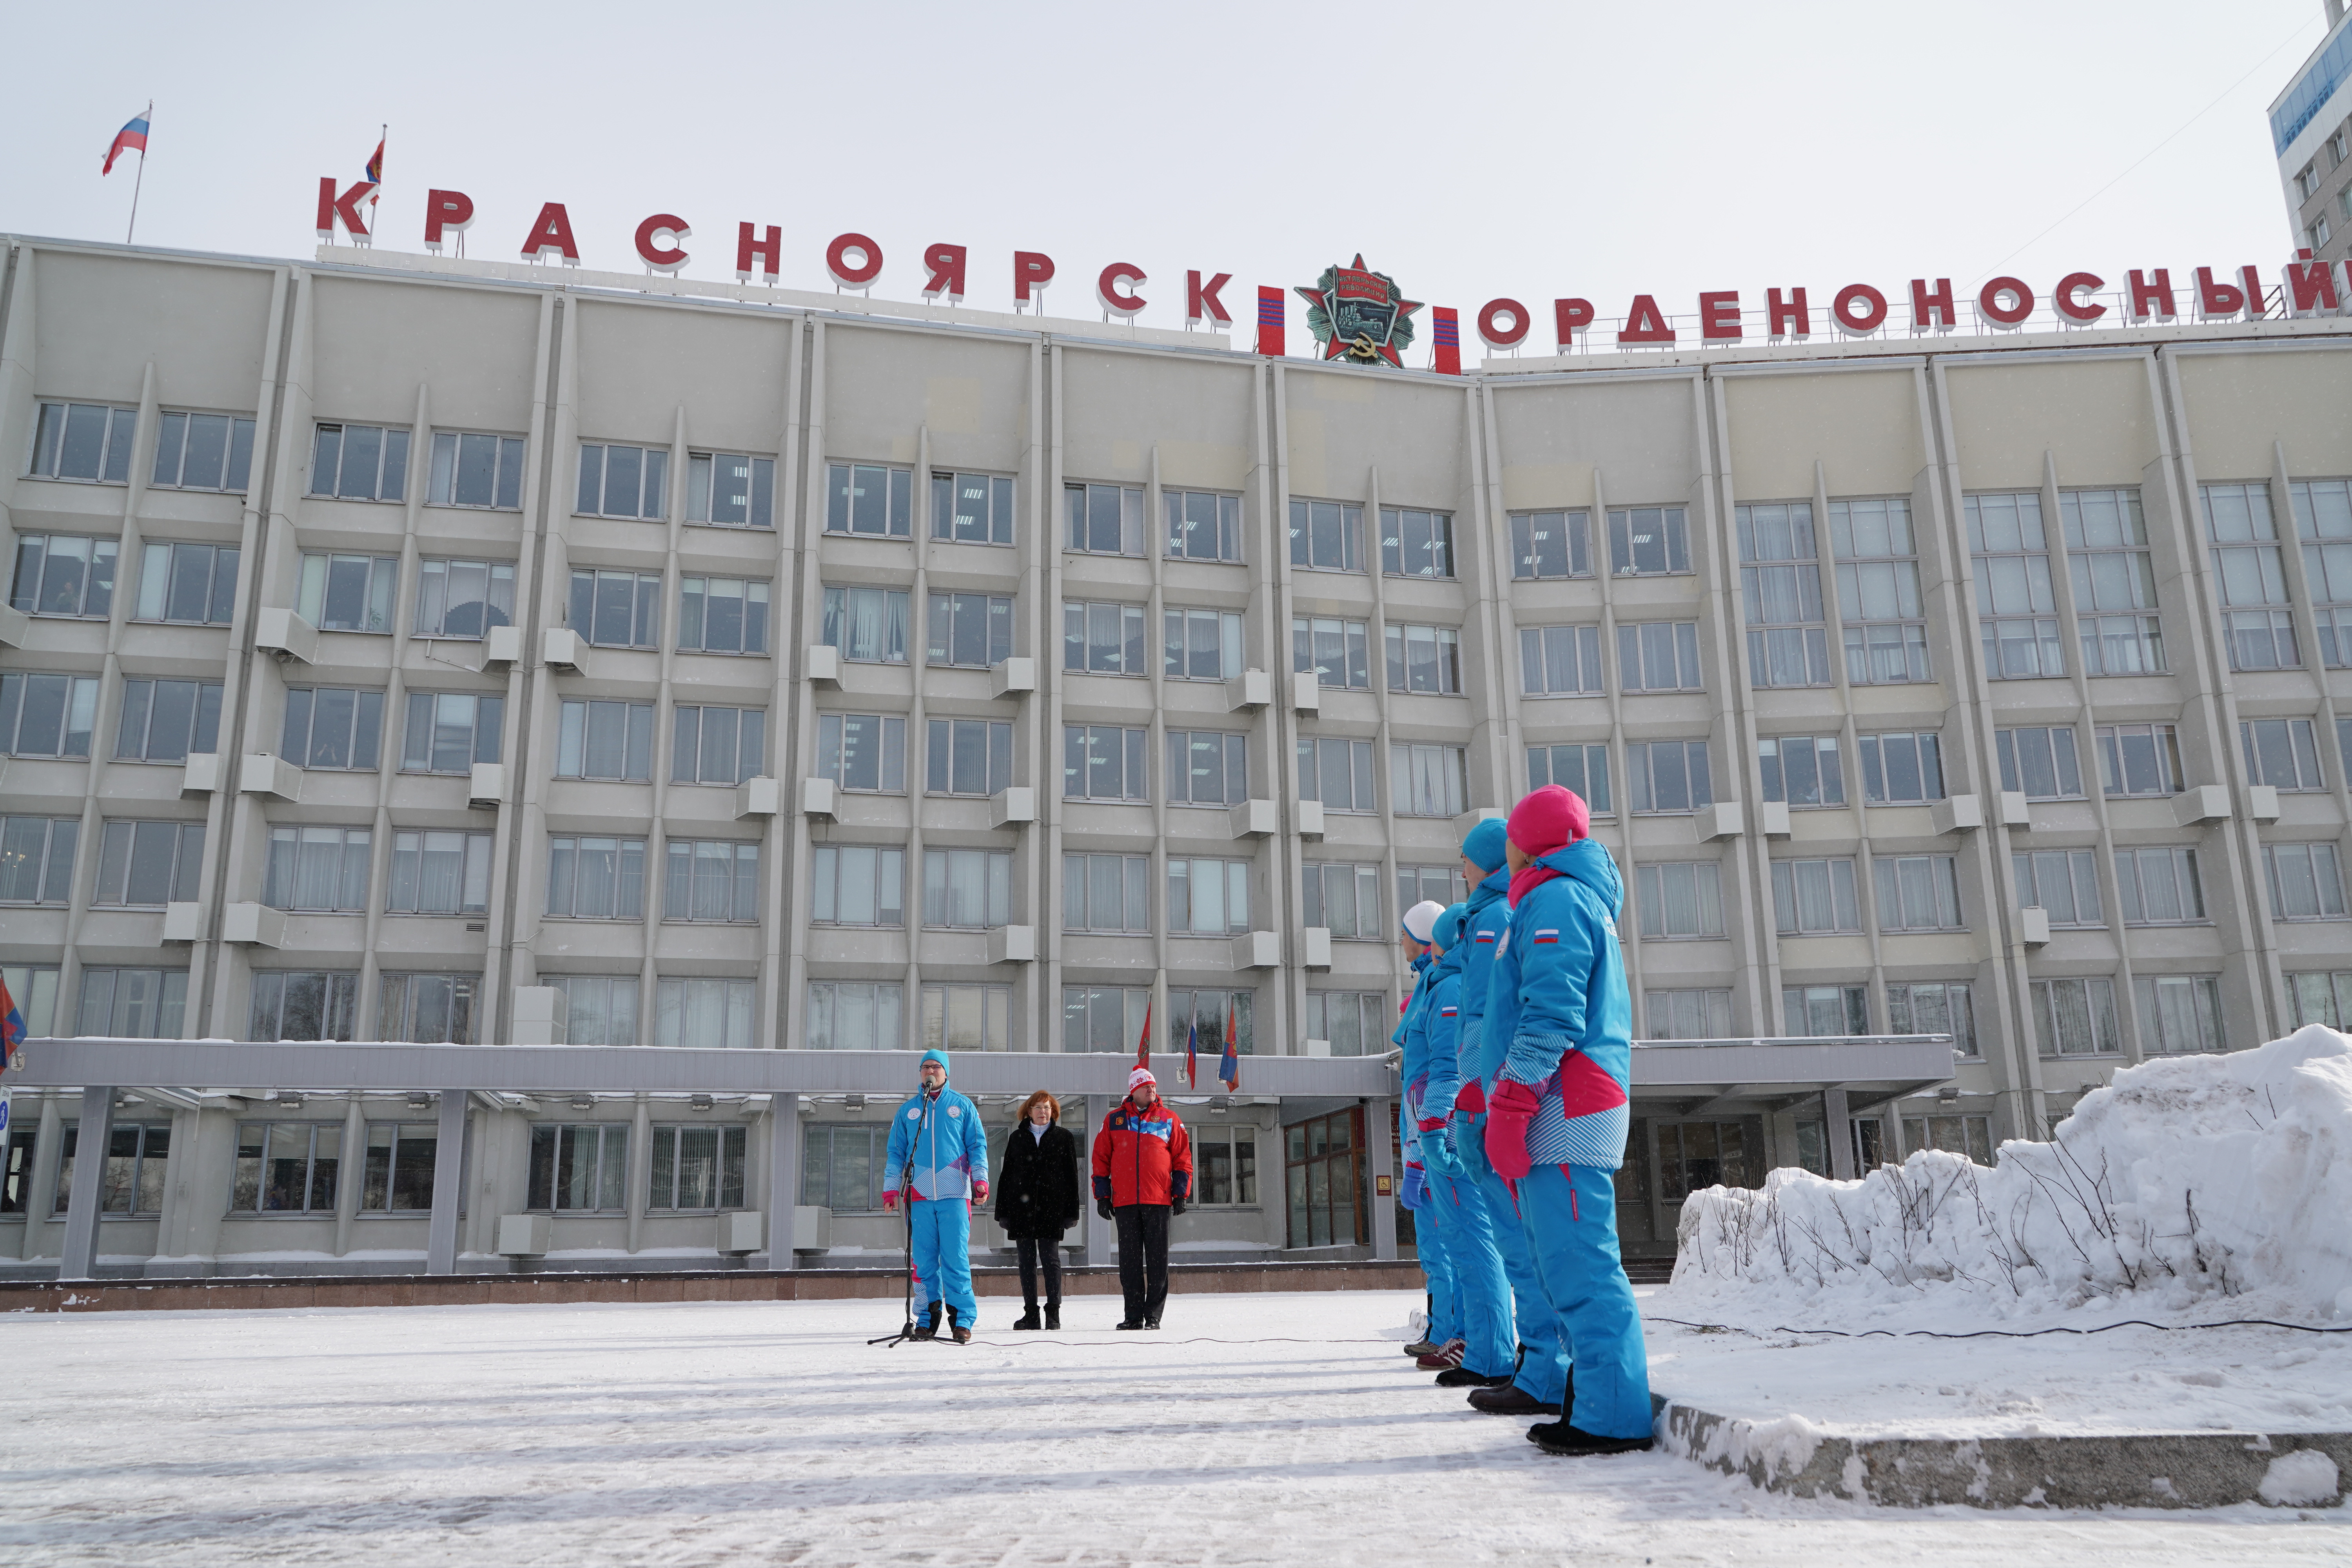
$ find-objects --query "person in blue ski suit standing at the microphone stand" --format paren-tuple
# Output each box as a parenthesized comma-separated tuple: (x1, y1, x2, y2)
(882, 1051, 988, 1345)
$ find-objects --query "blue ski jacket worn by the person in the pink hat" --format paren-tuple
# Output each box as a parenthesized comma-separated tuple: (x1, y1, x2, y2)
(1486, 839, 1632, 1171)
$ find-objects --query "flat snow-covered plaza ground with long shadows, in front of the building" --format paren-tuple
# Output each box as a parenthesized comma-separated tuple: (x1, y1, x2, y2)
(0, 1293, 2352, 1568)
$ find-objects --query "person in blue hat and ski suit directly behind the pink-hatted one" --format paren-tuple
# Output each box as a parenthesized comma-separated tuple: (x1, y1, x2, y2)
(1446, 818, 1569, 1415)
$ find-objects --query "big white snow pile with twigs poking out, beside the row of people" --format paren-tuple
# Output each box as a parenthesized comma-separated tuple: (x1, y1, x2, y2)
(1653, 1025, 2352, 1321)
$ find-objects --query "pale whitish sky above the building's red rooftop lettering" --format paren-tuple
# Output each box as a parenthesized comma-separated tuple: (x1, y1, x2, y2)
(0, 0, 2324, 334)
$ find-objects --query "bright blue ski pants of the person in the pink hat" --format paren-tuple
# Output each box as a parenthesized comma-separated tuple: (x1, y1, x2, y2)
(1517, 1166, 1651, 1436)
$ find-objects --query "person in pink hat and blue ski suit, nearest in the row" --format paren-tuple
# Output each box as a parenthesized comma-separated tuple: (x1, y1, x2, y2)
(1486, 785, 1653, 1455)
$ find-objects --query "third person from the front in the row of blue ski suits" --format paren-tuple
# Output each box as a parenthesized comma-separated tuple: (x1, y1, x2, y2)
(1406, 905, 1517, 1389)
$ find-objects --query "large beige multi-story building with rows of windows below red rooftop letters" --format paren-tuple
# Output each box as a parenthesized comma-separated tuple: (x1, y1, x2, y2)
(0, 240, 2352, 1267)
